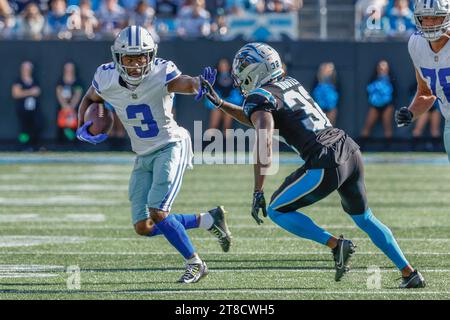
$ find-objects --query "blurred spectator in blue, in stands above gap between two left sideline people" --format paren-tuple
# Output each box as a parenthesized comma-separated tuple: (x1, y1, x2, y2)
(44, 0, 70, 39)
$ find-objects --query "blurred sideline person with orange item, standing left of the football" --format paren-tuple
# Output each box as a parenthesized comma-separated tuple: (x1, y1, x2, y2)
(56, 62, 83, 142)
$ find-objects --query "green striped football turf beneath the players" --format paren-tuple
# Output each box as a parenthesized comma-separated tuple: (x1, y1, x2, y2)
(0, 154, 450, 299)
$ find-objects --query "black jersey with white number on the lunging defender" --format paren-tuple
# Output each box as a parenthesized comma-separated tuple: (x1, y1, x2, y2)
(244, 77, 359, 168)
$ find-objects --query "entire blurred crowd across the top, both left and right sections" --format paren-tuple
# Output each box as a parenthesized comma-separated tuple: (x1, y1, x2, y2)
(0, 0, 415, 40)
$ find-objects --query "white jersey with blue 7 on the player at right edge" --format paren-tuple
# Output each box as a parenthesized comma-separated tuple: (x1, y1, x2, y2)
(408, 33, 450, 120)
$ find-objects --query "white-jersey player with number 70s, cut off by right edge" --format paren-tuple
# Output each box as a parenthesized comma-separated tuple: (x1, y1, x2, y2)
(395, 0, 450, 161)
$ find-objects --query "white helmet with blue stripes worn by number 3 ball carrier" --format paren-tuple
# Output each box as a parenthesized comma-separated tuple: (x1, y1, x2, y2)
(111, 26, 158, 85)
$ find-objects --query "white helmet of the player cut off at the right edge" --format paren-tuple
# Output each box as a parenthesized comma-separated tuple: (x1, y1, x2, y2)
(414, 0, 450, 41)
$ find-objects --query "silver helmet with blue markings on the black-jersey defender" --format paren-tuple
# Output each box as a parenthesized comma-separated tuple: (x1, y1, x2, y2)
(231, 43, 284, 96)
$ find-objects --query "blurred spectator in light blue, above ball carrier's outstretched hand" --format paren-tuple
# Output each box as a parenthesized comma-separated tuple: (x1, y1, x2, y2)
(177, 0, 211, 38)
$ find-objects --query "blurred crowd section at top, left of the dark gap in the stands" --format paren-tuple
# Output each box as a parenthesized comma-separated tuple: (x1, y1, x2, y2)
(0, 0, 303, 40)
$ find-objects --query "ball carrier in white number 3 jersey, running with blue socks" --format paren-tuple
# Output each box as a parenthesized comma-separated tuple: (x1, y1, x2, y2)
(77, 26, 231, 283)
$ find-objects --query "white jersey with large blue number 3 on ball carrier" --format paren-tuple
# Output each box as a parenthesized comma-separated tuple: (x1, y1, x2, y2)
(92, 59, 189, 155)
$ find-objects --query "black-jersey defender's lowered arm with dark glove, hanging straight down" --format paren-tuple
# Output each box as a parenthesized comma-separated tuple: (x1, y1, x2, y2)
(251, 111, 274, 224)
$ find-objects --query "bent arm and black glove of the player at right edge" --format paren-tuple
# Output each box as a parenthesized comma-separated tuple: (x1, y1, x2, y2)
(395, 69, 436, 127)
